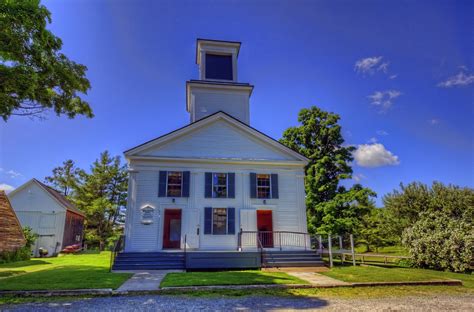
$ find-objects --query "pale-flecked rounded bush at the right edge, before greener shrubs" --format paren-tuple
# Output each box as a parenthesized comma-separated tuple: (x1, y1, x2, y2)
(403, 212, 474, 272)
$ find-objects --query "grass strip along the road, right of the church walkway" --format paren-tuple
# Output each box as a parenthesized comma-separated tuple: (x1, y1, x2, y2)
(321, 266, 474, 288)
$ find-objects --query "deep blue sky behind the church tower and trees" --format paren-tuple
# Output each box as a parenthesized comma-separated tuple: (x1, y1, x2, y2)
(0, 0, 474, 203)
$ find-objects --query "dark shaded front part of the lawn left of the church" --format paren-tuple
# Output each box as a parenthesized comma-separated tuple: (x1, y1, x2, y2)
(0, 265, 131, 290)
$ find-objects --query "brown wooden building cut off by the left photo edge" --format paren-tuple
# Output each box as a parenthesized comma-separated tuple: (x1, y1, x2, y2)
(0, 191, 26, 253)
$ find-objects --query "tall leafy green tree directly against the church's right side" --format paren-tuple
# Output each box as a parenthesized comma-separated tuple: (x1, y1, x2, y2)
(280, 106, 375, 234)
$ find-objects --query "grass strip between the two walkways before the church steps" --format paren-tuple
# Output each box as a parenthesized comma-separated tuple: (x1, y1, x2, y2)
(161, 271, 307, 287)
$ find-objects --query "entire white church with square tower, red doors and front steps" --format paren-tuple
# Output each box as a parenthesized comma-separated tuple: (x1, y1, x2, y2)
(114, 39, 320, 269)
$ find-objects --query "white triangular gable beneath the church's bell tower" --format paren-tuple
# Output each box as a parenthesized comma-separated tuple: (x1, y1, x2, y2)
(125, 112, 307, 164)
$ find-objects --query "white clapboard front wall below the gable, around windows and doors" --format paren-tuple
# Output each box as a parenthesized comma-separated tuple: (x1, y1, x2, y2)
(125, 162, 307, 251)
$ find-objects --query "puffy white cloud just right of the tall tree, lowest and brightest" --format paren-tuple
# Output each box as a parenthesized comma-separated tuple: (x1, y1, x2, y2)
(354, 143, 400, 167)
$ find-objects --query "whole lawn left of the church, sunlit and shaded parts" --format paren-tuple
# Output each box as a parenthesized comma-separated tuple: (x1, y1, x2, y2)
(0, 252, 131, 290)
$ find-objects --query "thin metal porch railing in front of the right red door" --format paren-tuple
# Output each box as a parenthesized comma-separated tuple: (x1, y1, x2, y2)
(238, 231, 313, 250)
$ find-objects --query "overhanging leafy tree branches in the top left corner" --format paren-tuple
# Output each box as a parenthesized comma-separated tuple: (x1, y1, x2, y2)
(0, 0, 93, 121)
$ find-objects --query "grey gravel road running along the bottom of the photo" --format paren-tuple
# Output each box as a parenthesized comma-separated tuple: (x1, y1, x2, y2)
(0, 295, 474, 311)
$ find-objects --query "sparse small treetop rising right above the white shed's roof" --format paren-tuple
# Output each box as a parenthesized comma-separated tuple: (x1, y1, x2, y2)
(45, 159, 83, 196)
